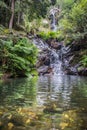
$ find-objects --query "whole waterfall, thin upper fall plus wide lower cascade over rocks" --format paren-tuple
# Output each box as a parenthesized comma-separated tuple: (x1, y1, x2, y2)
(33, 8, 63, 75)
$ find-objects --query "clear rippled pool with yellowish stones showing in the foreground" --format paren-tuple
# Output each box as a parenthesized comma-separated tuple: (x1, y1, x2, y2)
(0, 75, 87, 130)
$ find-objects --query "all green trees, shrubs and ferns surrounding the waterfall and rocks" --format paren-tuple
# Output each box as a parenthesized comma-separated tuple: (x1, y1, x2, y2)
(0, 0, 87, 75)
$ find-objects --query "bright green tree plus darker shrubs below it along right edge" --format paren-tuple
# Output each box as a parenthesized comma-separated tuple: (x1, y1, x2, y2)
(59, 0, 87, 67)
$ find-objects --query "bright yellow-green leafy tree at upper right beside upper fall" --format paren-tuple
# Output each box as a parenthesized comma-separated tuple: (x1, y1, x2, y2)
(59, 0, 87, 43)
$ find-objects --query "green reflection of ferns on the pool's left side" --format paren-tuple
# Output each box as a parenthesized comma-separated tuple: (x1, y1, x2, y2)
(0, 78, 36, 107)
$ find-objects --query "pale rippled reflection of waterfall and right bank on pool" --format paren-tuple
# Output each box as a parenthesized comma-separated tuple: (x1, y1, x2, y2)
(38, 75, 87, 108)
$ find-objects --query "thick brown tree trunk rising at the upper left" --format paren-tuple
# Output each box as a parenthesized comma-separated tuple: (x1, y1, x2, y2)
(9, 0, 15, 30)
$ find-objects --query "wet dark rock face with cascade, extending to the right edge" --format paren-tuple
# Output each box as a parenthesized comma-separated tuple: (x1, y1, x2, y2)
(33, 38, 87, 76)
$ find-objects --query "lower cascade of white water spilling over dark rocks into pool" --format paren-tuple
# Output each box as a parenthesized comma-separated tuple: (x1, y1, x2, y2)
(33, 38, 64, 75)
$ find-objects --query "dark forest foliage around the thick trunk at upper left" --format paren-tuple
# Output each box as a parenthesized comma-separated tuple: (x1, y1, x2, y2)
(0, 0, 50, 27)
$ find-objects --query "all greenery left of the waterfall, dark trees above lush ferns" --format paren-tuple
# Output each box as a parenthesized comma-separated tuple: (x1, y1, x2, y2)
(0, 0, 49, 77)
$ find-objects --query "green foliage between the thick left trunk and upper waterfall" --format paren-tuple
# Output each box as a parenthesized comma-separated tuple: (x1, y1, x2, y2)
(21, 0, 50, 32)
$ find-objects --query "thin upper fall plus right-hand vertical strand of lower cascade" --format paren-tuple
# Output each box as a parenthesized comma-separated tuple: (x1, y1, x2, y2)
(50, 7, 63, 74)
